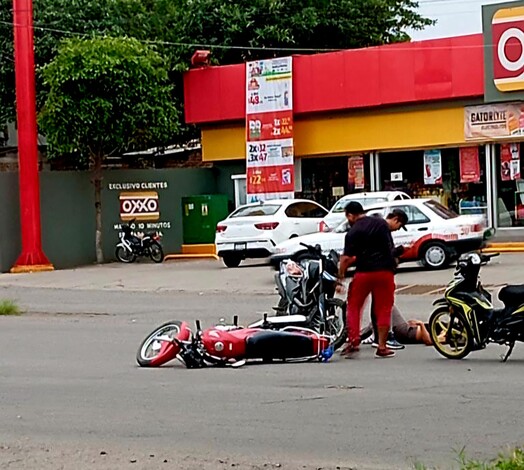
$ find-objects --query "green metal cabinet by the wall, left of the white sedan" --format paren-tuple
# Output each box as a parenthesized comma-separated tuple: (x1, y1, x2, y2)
(182, 194, 229, 245)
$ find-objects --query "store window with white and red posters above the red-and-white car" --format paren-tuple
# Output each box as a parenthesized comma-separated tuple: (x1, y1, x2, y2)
(379, 146, 487, 218)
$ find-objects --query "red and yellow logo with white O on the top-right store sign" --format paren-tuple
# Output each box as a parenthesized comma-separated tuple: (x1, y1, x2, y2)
(491, 6, 524, 93)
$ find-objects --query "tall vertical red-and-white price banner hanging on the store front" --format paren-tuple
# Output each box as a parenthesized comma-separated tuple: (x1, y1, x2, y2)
(246, 57, 295, 202)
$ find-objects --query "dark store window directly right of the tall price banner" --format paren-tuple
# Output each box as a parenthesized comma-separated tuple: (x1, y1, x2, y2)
(296, 154, 371, 209)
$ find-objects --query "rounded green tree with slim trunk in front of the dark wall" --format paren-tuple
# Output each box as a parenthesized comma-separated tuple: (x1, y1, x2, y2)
(39, 37, 179, 263)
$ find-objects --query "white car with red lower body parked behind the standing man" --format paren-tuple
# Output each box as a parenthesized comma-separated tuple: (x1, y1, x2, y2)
(271, 199, 494, 269)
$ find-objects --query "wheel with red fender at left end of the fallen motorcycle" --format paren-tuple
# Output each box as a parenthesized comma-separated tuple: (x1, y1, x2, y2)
(136, 320, 186, 367)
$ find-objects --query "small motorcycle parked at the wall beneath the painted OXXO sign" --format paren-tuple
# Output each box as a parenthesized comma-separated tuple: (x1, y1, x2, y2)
(115, 219, 164, 263)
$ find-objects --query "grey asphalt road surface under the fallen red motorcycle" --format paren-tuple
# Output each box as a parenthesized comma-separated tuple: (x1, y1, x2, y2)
(0, 257, 524, 470)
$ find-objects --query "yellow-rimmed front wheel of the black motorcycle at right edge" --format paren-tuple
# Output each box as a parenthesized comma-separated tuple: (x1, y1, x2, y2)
(429, 305, 473, 359)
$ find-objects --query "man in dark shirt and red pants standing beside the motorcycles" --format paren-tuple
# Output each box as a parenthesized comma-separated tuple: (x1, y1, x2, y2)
(339, 201, 407, 358)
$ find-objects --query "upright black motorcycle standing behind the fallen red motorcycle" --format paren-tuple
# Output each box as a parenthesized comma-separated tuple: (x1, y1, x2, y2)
(249, 243, 347, 350)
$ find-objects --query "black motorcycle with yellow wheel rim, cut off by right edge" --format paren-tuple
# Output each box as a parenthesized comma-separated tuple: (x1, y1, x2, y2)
(429, 253, 524, 362)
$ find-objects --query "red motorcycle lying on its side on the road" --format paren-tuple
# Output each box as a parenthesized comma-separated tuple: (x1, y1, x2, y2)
(136, 315, 333, 369)
